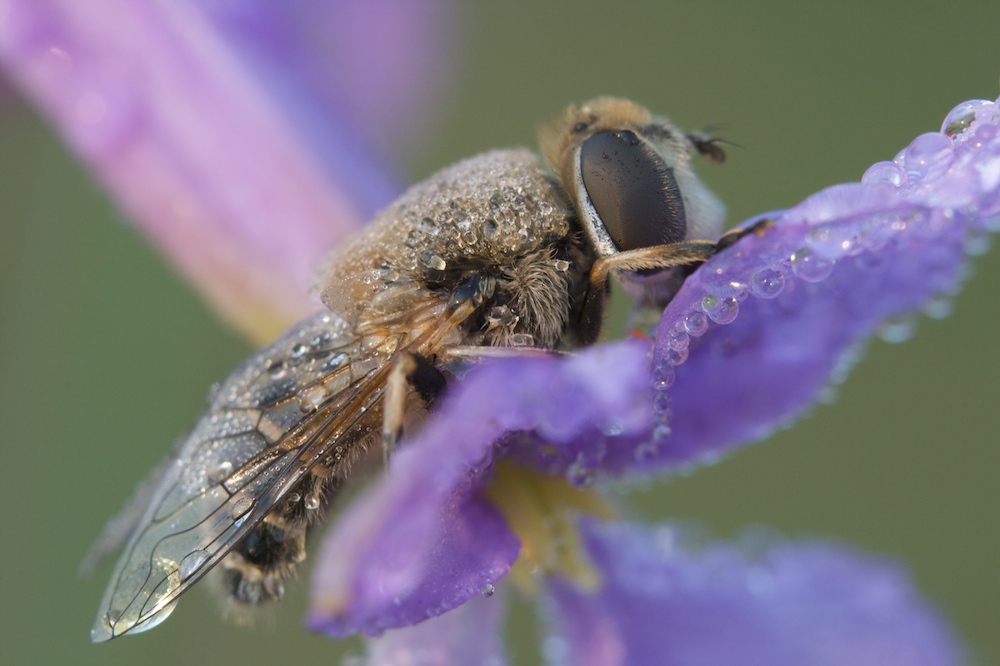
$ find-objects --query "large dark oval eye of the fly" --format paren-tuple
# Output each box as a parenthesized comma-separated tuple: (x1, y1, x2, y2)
(580, 130, 687, 251)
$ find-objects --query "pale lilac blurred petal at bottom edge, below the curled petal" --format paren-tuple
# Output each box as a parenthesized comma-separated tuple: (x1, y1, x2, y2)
(365, 588, 507, 666)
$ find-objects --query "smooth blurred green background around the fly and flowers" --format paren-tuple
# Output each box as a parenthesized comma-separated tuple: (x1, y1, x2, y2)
(0, 0, 1000, 664)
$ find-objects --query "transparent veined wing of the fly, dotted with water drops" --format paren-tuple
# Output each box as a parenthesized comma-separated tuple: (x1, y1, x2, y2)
(91, 312, 396, 642)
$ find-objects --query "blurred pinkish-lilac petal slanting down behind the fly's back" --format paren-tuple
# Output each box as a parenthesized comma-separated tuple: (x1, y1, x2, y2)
(0, 0, 450, 338)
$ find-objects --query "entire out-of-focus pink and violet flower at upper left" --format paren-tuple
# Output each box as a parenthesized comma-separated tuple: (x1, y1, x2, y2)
(0, 0, 450, 342)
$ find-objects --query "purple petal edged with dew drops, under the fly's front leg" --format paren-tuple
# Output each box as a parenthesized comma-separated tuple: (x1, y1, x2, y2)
(651, 96, 1000, 467)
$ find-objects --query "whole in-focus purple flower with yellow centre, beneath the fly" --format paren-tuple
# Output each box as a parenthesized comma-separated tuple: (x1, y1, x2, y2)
(310, 101, 1000, 664)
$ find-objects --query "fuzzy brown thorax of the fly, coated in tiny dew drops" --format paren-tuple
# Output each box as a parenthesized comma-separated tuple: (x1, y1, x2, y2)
(320, 150, 594, 347)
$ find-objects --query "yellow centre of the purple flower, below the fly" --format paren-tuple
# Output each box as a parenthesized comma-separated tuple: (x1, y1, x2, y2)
(486, 461, 615, 592)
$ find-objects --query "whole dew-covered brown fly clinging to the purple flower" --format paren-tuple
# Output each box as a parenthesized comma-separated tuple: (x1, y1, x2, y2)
(91, 98, 752, 642)
